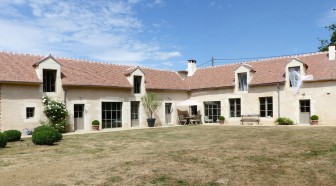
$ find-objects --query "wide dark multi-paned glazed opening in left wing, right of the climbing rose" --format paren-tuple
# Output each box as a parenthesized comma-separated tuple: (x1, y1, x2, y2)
(102, 102, 122, 129)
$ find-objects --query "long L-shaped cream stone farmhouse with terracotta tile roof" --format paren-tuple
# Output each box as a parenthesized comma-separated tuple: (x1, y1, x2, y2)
(0, 46, 336, 131)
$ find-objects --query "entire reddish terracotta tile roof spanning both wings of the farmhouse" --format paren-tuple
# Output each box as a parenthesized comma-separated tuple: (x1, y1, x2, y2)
(0, 52, 336, 90)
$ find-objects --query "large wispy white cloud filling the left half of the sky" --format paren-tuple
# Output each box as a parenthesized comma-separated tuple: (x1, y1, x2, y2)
(0, 0, 181, 65)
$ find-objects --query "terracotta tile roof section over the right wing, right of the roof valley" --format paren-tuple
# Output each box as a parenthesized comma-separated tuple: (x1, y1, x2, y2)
(187, 52, 336, 89)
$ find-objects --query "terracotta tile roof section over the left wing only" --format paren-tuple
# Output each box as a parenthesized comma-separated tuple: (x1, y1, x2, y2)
(0, 52, 187, 90)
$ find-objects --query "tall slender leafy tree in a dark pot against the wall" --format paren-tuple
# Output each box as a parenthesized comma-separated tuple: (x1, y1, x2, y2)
(141, 93, 161, 127)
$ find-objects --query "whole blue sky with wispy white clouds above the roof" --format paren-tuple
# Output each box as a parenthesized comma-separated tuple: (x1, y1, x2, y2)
(0, 0, 336, 70)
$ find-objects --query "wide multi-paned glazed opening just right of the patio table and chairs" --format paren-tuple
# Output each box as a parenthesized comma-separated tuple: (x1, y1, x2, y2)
(204, 101, 221, 123)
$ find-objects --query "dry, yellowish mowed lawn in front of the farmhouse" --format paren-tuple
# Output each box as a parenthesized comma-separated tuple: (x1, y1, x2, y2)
(0, 126, 336, 185)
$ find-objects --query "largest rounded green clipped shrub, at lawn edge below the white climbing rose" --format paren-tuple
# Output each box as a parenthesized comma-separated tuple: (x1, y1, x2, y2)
(32, 125, 63, 145)
